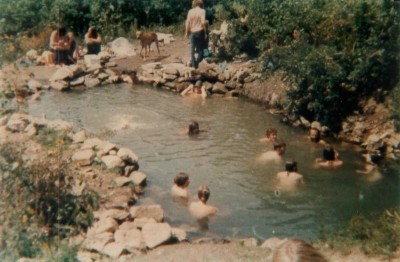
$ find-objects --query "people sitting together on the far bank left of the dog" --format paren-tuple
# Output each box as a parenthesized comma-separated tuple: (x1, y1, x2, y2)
(37, 26, 102, 65)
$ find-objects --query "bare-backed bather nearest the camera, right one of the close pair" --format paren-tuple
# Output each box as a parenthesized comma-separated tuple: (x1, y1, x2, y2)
(189, 186, 218, 222)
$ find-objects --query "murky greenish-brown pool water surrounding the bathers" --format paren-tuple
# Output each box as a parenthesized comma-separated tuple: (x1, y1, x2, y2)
(29, 86, 400, 239)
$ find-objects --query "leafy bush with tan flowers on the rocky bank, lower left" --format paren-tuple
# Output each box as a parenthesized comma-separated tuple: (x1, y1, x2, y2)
(0, 145, 97, 260)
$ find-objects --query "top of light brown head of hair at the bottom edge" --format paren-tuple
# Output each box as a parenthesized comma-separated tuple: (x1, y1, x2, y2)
(272, 238, 328, 262)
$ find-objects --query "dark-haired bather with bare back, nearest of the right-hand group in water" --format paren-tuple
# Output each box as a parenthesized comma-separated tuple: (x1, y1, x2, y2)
(276, 160, 304, 190)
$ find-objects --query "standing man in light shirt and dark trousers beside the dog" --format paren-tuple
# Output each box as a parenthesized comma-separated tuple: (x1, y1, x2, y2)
(185, 0, 206, 68)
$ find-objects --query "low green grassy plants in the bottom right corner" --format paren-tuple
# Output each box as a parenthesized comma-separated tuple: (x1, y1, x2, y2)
(328, 209, 400, 256)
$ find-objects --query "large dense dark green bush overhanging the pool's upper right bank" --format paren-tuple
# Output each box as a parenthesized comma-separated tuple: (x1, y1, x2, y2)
(238, 0, 400, 131)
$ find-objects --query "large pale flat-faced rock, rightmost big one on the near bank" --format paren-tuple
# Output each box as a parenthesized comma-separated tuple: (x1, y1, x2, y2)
(142, 223, 171, 249)
